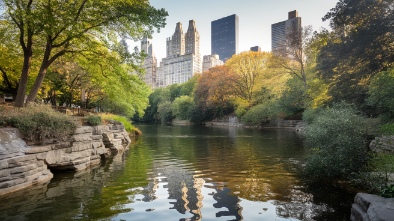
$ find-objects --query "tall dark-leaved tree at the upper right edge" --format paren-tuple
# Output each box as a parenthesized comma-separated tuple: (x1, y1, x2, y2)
(317, 0, 394, 107)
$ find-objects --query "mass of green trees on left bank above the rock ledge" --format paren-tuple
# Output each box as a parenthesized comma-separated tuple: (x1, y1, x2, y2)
(0, 0, 167, 117)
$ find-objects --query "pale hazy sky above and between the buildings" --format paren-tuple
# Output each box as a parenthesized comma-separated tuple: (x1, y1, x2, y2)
(135, 0, 338, 61)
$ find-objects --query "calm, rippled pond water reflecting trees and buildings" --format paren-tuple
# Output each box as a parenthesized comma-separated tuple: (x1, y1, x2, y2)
(0, 125, 354, 221)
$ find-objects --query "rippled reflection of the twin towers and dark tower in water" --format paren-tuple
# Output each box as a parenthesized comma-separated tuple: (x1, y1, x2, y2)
(143, 162, 243, 221)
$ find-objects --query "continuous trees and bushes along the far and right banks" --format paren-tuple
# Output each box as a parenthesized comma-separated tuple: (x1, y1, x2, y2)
(139, 0, 394, 193)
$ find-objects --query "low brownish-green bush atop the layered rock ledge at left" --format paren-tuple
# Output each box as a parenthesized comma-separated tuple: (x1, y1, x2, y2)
(0, 104, 77, 144)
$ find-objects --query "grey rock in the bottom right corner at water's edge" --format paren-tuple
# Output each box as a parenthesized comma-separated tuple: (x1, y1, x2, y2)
(350, 193, 394, 221)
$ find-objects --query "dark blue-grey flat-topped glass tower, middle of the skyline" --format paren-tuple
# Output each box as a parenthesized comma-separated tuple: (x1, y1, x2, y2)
(211, 14, 239, 62)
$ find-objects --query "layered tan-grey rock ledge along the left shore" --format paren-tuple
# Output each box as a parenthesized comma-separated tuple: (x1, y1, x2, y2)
(0, 122, 131, 196)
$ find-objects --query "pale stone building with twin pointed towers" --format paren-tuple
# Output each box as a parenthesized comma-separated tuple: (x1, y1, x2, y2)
(157, 20, 201, 87)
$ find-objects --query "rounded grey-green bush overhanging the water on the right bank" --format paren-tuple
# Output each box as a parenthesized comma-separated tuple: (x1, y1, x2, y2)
(304, 103, 369, 182)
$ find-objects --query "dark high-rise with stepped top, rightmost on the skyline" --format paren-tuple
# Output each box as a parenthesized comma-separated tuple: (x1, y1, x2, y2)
(271, 10, 301, 53)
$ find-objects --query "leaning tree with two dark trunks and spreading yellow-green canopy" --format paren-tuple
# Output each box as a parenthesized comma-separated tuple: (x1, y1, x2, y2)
(0, 0, 167, 107)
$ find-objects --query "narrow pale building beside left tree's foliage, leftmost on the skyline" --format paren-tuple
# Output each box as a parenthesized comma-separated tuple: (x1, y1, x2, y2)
(141, 38, 157, 88)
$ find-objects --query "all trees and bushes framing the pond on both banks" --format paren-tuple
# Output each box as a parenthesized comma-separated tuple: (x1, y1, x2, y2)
(0, 0, 394, 195)
